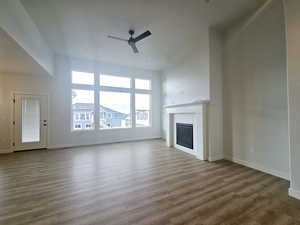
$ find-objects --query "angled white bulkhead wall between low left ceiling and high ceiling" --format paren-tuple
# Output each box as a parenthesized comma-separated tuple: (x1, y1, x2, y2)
(0, 0, 54, 75)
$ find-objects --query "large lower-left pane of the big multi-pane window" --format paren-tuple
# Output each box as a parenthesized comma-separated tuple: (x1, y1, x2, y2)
(72, 89, 95, 130)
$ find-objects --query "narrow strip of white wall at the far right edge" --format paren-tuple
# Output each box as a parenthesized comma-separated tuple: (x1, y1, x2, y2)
(285, 0, 300, 199)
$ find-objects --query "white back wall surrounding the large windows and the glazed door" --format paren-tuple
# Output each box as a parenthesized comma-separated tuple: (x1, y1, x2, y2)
(0, 56, 161, 152)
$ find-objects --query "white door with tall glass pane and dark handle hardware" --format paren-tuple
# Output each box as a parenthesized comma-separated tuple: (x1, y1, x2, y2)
(14, 94, 48, 151)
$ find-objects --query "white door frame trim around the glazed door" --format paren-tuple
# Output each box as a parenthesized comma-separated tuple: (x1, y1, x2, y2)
(9, 91, 50, 152)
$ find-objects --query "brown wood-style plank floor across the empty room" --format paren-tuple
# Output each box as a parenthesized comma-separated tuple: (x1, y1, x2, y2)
(0, 140, 300, 225)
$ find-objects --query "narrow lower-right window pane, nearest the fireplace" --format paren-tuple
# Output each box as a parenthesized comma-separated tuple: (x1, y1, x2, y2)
(135, 94, 151, 127)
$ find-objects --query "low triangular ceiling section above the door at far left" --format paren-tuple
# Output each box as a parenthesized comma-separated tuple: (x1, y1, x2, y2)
(0, 29, 46, 75)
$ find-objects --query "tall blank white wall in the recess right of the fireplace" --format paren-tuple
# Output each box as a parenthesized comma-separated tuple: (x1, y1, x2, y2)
(224, 0, 289, 179)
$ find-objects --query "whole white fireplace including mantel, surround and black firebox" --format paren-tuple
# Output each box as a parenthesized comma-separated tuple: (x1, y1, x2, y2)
(164, 99, 208, 160)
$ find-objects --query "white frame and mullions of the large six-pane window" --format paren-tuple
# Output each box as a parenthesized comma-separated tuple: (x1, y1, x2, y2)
(70, 69, 153, 132)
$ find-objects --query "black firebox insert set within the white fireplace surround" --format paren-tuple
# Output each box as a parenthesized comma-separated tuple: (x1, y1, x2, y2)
(176, 123, 194, 149)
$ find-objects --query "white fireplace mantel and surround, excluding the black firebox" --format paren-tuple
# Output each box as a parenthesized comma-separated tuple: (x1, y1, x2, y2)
(164, 100, 209, 160)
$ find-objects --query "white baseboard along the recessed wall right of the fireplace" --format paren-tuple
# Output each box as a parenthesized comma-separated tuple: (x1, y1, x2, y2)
(225, 157, 290, 181)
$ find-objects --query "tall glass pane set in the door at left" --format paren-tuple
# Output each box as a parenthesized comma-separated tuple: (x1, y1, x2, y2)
(22, 98, 40, 143)
